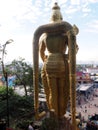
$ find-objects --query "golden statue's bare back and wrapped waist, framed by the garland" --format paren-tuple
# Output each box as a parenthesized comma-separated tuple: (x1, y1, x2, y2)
(44, 34, 67, 73)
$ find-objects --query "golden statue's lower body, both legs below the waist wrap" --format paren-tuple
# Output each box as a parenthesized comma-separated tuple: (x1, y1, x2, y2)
(47, 74, 69, 118)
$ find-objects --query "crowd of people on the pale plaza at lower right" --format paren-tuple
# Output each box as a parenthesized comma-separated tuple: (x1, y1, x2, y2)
(76, 87, 98, 130)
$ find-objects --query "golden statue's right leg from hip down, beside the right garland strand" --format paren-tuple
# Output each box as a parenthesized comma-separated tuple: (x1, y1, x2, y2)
(57, 59, 70, 117)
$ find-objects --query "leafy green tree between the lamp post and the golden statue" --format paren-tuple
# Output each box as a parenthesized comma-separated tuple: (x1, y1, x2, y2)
(6, 58, 33, 96)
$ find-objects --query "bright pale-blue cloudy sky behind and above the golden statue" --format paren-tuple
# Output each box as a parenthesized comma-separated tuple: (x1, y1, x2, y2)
(0, 0, 98, 64)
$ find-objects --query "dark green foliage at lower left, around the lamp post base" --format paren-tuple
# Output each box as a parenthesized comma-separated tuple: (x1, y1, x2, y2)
(0, 86, 34, 127)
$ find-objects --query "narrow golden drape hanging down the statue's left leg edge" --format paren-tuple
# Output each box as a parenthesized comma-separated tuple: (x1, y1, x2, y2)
(41, 67, 50, 109)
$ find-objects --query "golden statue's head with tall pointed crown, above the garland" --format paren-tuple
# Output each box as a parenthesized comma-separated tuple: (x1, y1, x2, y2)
(50, 3, 63, 23)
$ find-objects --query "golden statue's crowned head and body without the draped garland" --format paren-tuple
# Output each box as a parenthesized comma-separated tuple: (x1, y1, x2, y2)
(39, 3, 78, 118)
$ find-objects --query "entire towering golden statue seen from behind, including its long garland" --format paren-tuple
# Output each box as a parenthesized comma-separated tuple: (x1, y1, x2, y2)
(33, 3, 79, 129)
